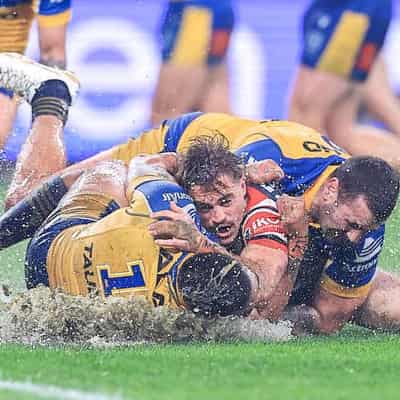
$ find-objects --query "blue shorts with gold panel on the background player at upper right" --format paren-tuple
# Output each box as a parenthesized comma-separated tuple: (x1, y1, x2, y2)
(301, 0, 392, 82)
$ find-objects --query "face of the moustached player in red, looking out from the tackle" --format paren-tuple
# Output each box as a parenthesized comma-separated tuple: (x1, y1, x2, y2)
(189, 174, 246, 246)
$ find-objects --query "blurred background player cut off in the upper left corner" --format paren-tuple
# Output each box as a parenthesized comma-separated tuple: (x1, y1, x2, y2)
(0, 0, 71, 149)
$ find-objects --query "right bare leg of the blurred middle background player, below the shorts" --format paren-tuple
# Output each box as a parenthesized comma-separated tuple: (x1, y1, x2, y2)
(199, 63, 230, 113)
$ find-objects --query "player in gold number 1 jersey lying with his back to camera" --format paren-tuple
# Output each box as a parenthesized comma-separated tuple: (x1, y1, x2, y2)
(26, 158, 257, 316)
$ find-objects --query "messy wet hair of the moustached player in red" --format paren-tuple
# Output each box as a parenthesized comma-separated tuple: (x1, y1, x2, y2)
(180, 132, 244, 191)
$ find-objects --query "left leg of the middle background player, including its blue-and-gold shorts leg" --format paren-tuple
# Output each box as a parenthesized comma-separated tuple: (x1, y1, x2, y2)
(151, 2, 213, 125)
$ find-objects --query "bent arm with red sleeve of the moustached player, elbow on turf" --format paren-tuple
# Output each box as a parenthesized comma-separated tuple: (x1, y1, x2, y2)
(241, 195, 308, 320)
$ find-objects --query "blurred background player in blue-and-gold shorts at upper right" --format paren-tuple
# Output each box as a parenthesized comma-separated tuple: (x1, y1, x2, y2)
(289, 0, 400, 166)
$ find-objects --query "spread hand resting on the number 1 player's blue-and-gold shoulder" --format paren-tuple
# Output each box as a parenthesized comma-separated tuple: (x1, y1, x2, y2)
(149, 203, 206, 253)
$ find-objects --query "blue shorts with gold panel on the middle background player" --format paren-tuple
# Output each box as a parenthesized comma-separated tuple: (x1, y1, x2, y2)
(161, 0, 234, 66)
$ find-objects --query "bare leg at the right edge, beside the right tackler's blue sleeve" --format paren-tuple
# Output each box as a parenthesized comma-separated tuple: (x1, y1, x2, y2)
(355, 271, 400, 332)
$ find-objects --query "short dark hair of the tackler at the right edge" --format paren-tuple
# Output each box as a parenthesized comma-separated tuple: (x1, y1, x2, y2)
(331, 156, 400, 223)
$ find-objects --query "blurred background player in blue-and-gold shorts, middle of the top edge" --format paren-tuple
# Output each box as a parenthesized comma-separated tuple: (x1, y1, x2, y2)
(151, 0, 234, 126)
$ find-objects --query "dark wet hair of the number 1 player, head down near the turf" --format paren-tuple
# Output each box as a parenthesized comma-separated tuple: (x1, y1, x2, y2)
(177, 253, 251, 317)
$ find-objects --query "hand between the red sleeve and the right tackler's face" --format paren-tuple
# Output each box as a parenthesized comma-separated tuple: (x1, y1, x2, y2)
(277, 194, 308, 236)
